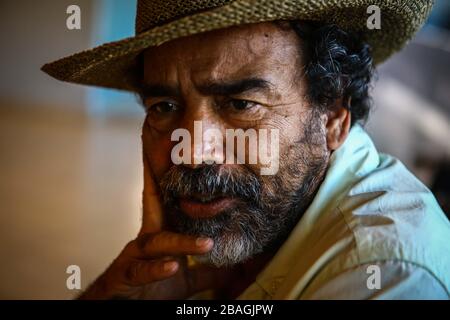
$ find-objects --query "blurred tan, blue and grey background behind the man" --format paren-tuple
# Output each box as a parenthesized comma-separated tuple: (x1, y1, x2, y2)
(0, 0, 450, 299)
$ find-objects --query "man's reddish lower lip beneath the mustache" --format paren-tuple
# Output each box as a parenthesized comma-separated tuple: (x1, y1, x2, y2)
(179, 197, 236, 218)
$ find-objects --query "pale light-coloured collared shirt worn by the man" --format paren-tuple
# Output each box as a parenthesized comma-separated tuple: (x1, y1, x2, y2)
(238, 125, 450, 299)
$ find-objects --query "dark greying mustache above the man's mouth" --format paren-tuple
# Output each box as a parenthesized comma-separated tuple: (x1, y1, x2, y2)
(160, 164, 261, 203)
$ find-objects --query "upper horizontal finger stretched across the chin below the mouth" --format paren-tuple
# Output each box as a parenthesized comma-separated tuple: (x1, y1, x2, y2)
(136, 231, 214, 258)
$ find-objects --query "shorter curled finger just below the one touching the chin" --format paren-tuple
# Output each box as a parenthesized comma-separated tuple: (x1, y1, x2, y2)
(125, 260, 179, 286)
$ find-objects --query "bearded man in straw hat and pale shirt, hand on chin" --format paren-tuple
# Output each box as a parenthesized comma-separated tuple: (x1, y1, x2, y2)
(43, 0, 450, 299)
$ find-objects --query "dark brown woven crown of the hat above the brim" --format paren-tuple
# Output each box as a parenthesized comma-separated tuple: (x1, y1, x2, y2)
(136, 0, 234, 34)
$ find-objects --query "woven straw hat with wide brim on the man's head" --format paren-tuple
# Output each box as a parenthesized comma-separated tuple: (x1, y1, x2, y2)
(42, 0, 433, 91)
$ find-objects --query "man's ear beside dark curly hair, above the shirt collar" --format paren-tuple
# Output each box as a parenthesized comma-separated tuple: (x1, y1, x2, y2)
(326, 98, 351, 151)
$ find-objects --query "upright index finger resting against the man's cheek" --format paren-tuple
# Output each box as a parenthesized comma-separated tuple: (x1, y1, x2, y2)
(139, 150, 163, 234)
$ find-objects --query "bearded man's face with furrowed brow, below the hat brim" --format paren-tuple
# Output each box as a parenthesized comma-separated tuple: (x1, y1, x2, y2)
(143, 23, 329, 266)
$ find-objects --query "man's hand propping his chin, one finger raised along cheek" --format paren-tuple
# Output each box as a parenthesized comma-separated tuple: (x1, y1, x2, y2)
(79, 152, 227, 299)
